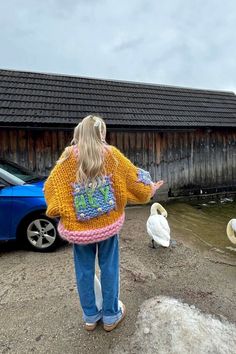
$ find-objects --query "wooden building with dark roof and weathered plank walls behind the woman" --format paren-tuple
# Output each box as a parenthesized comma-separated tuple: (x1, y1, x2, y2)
(0, 70, 236, 195)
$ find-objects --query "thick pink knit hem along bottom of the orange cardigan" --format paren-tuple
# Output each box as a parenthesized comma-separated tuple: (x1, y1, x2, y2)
(58, 213, 125, 245)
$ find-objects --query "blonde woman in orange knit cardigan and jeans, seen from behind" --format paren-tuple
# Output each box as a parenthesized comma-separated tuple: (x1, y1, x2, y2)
(44, 115, 163, 331)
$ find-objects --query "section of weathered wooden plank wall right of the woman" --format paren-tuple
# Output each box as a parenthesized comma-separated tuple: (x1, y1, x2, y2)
(109, 129, 236, 189)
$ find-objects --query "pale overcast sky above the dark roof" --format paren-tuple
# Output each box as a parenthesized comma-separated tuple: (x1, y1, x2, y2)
(0, 0, 236, 91)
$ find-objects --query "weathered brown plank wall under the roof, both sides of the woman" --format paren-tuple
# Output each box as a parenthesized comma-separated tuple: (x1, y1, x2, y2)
(0, 129, 236, 189)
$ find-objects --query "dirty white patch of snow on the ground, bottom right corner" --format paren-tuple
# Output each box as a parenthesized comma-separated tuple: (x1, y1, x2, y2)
(112, 296, 236, 354)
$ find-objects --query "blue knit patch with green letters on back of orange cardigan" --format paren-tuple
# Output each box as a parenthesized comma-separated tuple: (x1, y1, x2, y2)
(72, 176, 116, 221)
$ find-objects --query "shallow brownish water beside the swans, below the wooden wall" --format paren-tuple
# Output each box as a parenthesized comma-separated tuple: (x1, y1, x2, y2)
(166, 198, 236, 255)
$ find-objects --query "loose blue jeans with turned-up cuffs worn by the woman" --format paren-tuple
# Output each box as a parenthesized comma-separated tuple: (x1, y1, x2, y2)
(73, 235, 122, 324)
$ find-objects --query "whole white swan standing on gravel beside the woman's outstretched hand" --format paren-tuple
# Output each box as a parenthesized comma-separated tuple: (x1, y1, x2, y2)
(147, 203, 170, 248)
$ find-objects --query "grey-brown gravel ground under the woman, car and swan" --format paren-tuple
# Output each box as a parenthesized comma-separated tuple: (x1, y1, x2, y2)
(0, 207, 236, 354)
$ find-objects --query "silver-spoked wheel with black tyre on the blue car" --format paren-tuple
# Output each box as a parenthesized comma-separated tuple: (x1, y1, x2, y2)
(23, 214, 61, 252)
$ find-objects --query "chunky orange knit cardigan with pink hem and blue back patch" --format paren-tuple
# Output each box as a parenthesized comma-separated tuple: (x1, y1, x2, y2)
(44, 146, 156, 244)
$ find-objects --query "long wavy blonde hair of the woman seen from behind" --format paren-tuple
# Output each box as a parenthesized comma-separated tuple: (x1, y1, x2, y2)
(58, 115, 106, 187)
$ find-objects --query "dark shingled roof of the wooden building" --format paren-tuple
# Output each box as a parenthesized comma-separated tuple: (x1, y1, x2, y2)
(0, 70, 236, 128)
